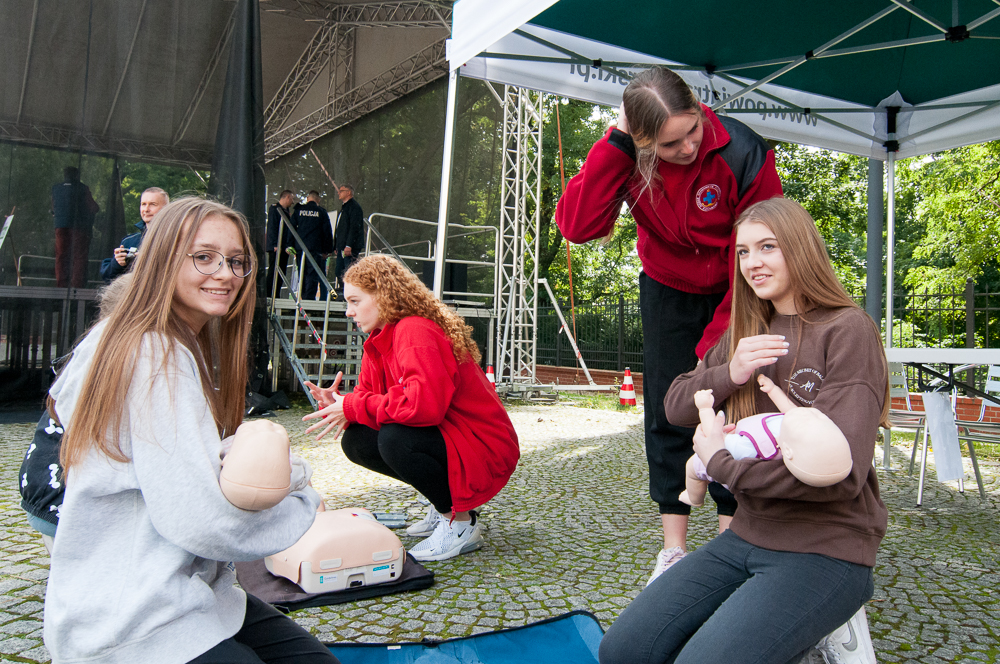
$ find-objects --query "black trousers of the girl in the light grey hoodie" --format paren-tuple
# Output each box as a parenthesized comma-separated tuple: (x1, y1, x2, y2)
(188, 594, 340, 664)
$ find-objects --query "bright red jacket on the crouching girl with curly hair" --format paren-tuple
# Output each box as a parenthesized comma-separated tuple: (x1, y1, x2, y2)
(344, 316, 520, 512)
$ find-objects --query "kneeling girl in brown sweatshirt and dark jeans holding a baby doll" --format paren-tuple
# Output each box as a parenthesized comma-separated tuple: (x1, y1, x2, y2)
(600, 198, 889, 664)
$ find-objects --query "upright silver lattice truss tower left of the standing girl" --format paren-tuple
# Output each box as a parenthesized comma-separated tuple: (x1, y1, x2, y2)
(491, 86, 544, 385)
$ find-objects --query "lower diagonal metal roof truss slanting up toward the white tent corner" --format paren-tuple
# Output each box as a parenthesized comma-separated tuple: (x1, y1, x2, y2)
(264, 39, 448, 161)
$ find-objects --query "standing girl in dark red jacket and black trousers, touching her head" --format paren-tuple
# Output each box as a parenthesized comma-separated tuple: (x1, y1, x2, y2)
(556, 67, 781, 582)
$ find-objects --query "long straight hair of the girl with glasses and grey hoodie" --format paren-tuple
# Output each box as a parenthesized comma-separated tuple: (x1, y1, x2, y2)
(60, 197, 256, 470)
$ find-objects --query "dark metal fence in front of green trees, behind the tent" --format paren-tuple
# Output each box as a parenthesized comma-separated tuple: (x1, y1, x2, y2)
(537, 279, 1000, 383)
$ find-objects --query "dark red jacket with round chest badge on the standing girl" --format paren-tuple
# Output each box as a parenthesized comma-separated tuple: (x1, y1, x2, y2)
(556, 105, 781, 358)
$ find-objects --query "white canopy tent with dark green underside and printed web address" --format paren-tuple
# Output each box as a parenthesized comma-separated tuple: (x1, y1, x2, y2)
(435, 0, 1000, 364)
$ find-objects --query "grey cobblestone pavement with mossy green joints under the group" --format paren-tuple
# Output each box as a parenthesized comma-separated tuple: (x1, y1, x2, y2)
(0, 404, 1000, 662)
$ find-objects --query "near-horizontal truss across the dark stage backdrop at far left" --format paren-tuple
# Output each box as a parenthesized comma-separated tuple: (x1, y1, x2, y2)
(0, 121, 212, 168)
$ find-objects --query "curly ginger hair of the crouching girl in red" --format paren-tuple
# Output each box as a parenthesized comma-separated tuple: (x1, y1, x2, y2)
(344, 254, 482, 364)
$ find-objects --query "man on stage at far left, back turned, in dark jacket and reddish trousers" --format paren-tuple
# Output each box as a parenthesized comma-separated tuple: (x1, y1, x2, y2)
(52, 166, 101, 288)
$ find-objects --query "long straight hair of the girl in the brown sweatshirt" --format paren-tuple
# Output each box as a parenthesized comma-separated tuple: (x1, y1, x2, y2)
(726, 198, 890, 427)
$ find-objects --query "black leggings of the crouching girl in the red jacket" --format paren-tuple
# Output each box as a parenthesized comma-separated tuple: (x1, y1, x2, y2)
(341, 424, 451, 514)
